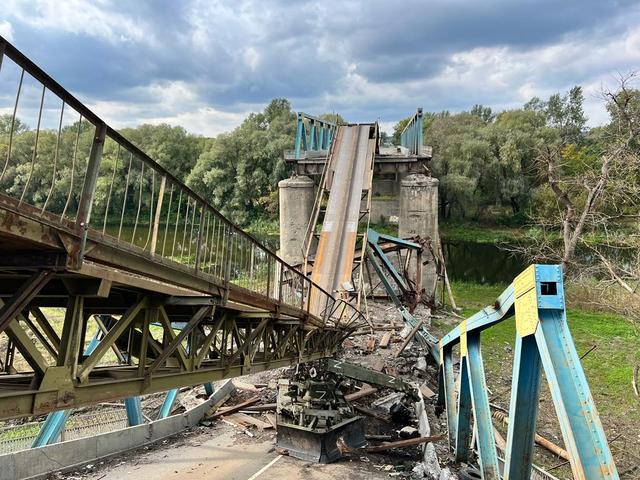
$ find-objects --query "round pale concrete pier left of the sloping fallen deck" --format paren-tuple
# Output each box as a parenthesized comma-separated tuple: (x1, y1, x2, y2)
(278, 176, 315, 265)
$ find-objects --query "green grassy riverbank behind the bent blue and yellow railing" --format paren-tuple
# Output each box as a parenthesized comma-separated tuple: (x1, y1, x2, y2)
(433, 282, 640, 473)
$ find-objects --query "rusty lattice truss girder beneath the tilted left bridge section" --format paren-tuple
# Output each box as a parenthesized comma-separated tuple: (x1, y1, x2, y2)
(0, 288, 350, 418)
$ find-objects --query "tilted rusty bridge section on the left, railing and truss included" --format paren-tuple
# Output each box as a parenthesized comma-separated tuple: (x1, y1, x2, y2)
(0, 38, 362, 418)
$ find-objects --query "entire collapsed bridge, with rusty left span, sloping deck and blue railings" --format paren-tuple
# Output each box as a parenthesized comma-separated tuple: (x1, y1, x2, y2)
(0, 37, 618, 479)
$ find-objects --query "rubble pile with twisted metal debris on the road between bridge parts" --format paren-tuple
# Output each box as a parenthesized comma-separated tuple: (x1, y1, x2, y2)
(200, 304, 455, 479)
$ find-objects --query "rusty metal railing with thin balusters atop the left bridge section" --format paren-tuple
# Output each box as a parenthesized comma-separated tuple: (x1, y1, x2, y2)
(0, 37, 359, 325)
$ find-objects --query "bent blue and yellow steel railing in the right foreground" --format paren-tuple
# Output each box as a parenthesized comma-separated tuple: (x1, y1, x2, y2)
(438, 265, 619, 480)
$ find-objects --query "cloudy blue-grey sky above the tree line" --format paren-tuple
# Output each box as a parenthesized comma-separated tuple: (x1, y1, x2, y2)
(0, 0, 640, 135)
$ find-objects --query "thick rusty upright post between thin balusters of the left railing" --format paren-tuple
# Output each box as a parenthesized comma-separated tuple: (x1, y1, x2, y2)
(73, 123, 107, 268)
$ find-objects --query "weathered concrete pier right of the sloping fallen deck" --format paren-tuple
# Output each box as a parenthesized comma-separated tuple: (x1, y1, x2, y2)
(398, 174, 440, 300)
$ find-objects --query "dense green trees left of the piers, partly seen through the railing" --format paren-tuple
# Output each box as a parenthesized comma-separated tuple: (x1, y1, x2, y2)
(0, 99, 295, 229)
